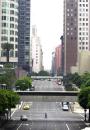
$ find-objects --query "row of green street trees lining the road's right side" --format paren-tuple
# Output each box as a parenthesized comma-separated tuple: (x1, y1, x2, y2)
(63, 73, 90, 122)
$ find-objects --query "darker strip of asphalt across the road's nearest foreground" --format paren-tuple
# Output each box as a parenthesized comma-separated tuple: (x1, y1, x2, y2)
(0, 120, 85, 130)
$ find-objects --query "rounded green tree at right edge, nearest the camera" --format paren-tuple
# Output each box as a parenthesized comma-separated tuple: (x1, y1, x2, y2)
(78, 87, 90, 122)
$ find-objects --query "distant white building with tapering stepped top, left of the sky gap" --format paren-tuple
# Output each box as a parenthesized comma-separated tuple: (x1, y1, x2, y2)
(31, 25, 43, 73)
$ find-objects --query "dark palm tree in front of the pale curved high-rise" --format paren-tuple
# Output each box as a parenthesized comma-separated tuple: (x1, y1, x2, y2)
(1, 42, 13, 63)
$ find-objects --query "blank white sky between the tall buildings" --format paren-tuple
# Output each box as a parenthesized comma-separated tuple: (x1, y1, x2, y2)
(31, 0, 63, 69)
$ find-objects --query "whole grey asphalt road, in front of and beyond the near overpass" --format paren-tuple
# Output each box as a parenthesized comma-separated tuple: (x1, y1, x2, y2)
(0, 80, 85, 130)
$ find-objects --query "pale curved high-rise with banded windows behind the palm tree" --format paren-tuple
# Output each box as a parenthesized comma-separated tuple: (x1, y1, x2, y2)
(0, 0, 18, 66)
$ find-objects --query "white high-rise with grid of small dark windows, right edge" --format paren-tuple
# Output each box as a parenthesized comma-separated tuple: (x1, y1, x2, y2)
(78, 0, 90, 52)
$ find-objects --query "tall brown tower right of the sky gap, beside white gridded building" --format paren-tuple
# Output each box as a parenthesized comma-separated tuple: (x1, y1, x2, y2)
(63, 0, 78, 75)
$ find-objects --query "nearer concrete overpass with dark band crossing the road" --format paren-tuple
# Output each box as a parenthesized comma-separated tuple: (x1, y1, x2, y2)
(16, 91, 79, 102)
